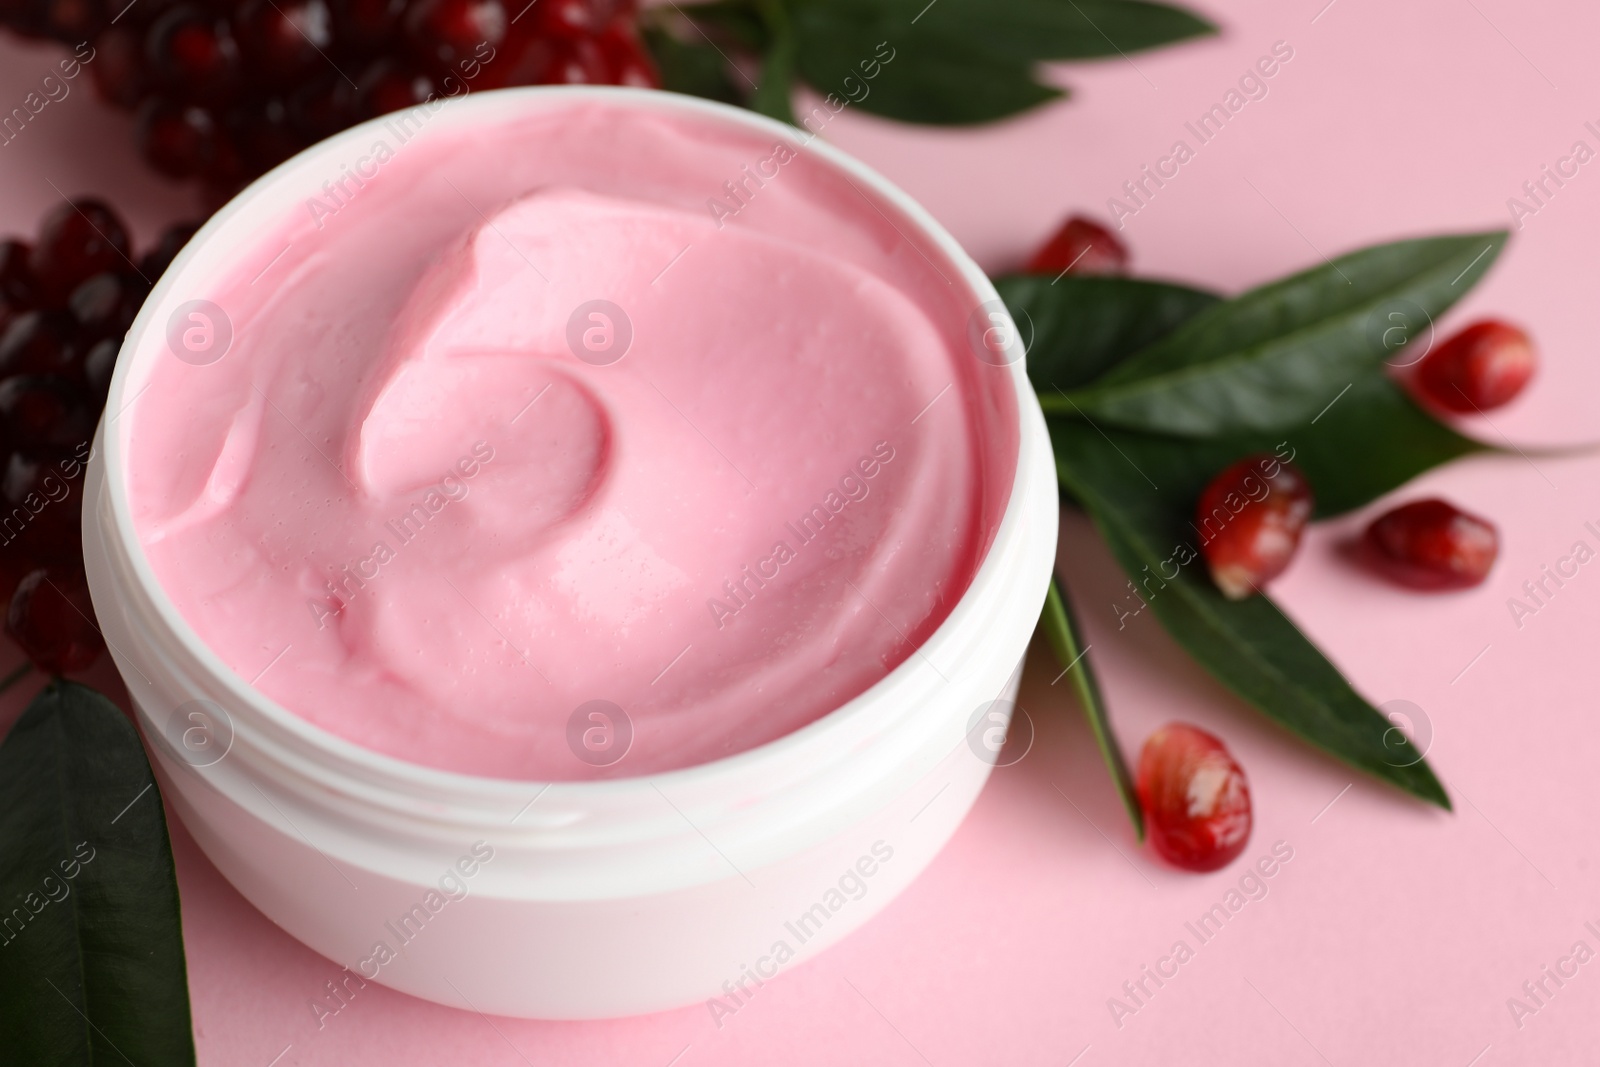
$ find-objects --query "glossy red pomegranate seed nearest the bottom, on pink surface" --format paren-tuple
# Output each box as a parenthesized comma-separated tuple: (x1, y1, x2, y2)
(1134, 723, 1251, 870)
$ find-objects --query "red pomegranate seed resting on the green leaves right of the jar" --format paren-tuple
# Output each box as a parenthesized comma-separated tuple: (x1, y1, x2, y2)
(1195, 453, 1312, 600)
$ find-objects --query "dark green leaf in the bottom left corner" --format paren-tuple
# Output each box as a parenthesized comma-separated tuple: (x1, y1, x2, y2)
(0, 680, 195, 1067)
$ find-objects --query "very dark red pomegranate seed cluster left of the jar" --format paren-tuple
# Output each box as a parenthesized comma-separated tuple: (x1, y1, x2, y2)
(0, 200, 194, 673)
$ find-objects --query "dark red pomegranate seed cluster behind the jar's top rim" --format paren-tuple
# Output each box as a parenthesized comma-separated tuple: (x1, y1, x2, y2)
(0, 0, 659, 200)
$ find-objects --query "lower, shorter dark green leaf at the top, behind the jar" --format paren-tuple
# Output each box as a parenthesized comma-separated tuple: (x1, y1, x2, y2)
(794, 3, 1066, 133)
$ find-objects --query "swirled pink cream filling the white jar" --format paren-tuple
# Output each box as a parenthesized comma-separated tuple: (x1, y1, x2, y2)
(125, 99, 1018, 781)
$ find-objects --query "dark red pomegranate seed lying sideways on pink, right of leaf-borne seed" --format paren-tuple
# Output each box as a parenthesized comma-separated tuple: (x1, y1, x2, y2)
(1362, 498, 1499, 589)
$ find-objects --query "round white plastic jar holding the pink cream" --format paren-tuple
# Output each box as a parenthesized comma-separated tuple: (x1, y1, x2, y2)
(83, 88, 1056, 1019)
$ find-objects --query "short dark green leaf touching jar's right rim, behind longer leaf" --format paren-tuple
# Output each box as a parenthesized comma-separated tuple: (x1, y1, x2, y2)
(994, 274, 1219, 394)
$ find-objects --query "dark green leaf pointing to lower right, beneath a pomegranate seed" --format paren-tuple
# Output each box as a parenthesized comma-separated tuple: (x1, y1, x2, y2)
(1051, 419, 1450, 808)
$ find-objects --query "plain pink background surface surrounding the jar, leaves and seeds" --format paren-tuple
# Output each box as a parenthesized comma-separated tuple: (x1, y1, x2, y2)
(0, 0, 1600, 1067)
